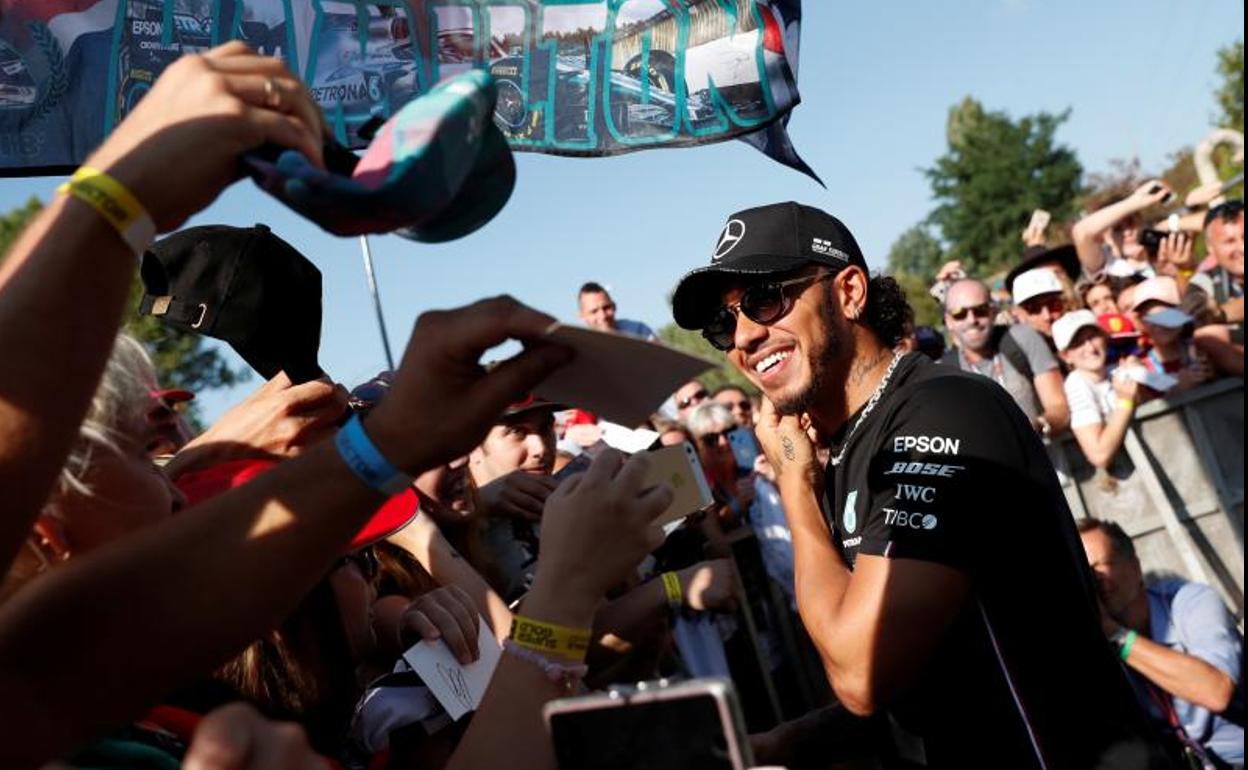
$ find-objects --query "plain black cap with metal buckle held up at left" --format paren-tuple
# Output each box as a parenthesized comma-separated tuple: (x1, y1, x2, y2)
(139, 225, 323, 383)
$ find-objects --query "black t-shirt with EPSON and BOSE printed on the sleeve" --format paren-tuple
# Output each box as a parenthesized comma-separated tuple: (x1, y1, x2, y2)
(825, 354, 1168, 770)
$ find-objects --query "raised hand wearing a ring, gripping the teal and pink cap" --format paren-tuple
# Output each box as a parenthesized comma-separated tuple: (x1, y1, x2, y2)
(86, 41, 323, 232)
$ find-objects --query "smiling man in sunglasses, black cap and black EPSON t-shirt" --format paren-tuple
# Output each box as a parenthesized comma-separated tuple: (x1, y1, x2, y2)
(673, 203, 1164, 770)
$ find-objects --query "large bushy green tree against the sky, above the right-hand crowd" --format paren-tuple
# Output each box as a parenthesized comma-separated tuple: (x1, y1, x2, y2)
(925, 96, 1083, 275)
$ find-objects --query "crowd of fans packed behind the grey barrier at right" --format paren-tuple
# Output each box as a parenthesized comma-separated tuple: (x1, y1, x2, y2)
(932, 181, 1244, 469)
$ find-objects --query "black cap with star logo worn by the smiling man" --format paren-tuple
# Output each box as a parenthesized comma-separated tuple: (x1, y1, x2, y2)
(671, 201, 867, 329)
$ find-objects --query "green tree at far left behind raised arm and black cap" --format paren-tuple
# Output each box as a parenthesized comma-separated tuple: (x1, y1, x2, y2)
(0, 197, 251, 401)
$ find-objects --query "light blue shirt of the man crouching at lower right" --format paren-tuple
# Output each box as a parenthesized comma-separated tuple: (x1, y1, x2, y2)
(1132, 580, 1244, 763)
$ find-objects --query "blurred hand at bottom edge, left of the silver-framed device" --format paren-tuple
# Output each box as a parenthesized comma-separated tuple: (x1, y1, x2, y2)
(182, 703, 329, 770)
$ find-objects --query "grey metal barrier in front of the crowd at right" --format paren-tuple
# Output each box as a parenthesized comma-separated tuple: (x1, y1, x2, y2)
(1050, 378, 1244, 624)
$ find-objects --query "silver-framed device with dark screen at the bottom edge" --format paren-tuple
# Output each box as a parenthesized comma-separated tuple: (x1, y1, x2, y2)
(542, 679, 754, 770)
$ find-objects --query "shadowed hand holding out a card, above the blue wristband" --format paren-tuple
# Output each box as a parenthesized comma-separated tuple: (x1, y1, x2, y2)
(366, 297, 573, 473)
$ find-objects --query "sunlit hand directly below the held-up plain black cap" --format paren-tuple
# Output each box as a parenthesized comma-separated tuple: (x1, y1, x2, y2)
(165, 372, 348, 478)
